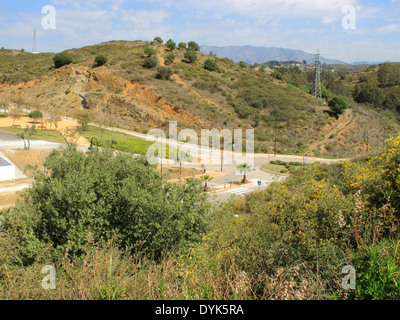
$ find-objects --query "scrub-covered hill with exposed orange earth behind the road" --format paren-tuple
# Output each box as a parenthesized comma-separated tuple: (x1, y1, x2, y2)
(0, 41, 399, 157)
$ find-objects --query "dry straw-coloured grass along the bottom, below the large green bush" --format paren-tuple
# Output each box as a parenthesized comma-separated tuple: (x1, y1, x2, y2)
(0, 247, 316, 300)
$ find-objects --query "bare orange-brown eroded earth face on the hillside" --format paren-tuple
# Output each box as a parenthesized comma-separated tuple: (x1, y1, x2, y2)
(0, 65, 209, 130)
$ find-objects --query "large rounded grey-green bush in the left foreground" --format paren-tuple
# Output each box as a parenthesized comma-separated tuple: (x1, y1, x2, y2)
(15, 150, 210, 259)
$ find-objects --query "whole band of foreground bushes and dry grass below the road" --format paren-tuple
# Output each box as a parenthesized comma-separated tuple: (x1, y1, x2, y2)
(0, 137, 400, 299)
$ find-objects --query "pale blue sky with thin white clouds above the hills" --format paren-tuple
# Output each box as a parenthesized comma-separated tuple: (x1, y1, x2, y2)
(0, 0, 400, 62)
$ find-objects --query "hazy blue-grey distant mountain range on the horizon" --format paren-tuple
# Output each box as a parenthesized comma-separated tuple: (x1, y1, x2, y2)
(200, 45, 394, 65)
